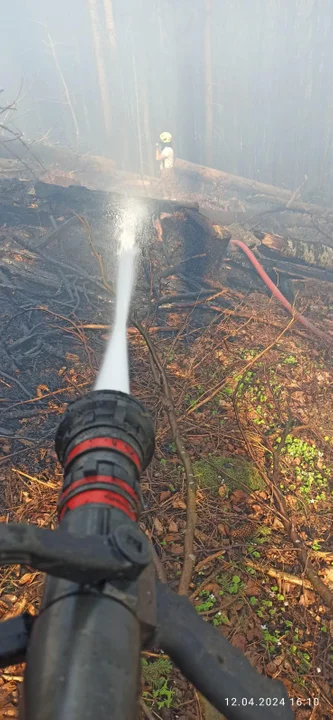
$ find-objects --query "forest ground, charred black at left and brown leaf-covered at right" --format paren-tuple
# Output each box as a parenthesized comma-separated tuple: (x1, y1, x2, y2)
(0, 172, 333, 720)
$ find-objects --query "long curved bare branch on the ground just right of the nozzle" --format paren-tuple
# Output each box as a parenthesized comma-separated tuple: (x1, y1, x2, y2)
(136, 322, 196, 595)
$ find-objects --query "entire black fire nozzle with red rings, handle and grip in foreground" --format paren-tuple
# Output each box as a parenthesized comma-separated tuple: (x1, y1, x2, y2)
(0, 390, 294, 720)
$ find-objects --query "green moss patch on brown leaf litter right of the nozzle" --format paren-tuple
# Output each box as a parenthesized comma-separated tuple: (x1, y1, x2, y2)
(193, 455, 265, 495)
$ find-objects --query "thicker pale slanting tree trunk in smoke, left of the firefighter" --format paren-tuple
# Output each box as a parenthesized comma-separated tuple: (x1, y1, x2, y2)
(88, 0, 112, 142)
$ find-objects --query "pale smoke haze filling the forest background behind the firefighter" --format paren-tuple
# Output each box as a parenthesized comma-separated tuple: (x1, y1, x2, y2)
(0, 0, 333, 201)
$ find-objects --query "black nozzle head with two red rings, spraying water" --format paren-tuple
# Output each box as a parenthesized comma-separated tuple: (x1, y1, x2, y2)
(56, 390, 155, 521)
